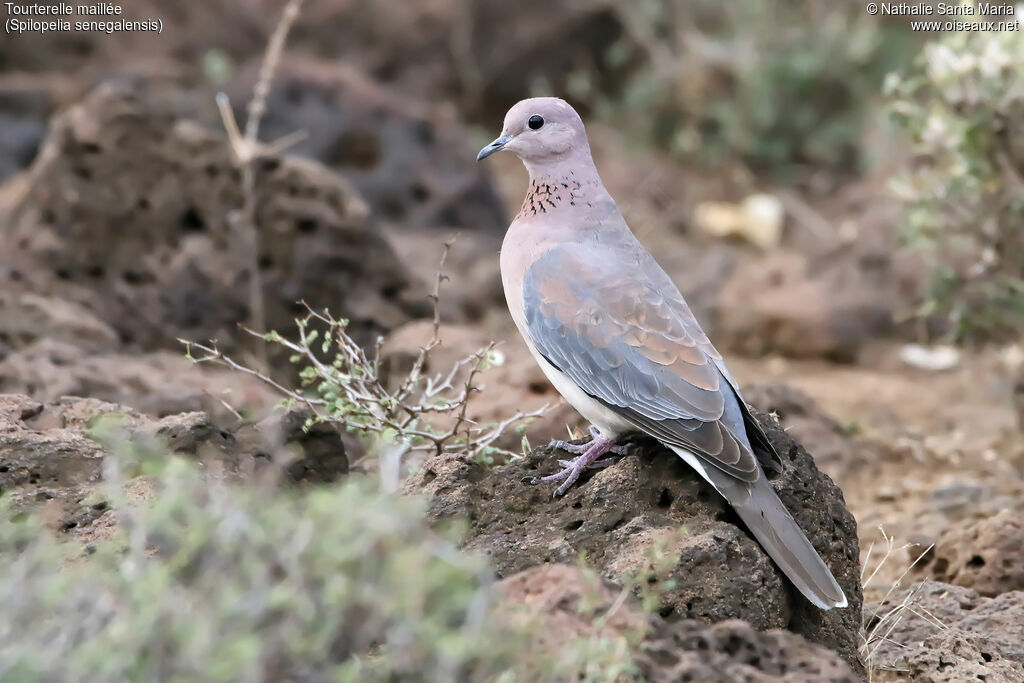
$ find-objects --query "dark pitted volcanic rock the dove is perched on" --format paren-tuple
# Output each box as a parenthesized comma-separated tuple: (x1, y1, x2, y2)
(406, 405, 862, 671)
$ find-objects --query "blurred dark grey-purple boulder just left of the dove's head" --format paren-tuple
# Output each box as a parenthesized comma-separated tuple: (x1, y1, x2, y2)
(228, 57, 508, 232)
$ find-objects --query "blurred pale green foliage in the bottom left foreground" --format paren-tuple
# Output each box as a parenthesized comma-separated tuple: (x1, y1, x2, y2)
(0, 448, 519, 682)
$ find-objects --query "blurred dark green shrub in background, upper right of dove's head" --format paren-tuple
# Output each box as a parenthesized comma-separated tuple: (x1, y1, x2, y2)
(571, 0, 918, 179)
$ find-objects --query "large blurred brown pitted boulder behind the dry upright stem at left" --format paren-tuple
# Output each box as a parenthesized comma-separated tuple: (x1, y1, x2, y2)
(0, 80, 426, 356)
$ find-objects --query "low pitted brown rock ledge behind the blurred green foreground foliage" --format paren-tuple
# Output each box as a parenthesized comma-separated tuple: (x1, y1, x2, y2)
(0, 394, 348, 531)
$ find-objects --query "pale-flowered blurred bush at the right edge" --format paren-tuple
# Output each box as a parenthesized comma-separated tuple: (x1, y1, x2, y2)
(886, 17, 1024, 339)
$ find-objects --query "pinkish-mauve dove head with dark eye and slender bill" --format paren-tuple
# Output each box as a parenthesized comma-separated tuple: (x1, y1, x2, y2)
(476, 97, 590, 168)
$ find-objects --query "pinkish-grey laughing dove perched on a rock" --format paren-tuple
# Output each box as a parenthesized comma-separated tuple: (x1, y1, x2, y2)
(477, 97, 847, 609)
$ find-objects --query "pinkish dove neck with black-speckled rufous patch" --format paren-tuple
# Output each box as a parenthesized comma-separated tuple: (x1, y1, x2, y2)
(516, 158, 614, 220)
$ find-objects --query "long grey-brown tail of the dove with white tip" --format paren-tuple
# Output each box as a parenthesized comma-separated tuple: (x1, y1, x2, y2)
(673, 449, 847, 609)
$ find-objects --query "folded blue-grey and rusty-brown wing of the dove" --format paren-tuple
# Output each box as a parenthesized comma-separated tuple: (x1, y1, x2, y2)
(523, 244, 777, 481)
